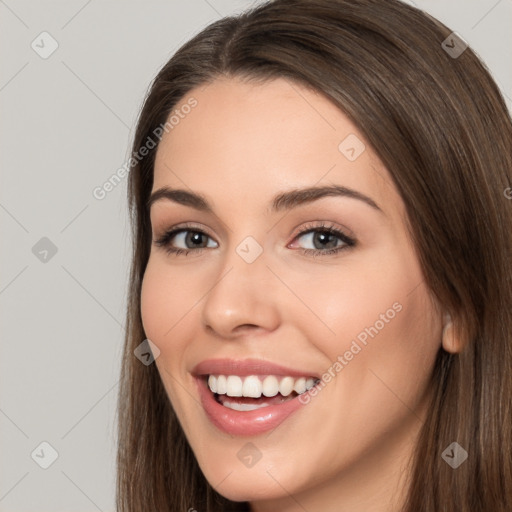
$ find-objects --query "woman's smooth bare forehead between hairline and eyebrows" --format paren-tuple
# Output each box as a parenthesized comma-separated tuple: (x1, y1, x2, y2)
(153, 78, 397, 217)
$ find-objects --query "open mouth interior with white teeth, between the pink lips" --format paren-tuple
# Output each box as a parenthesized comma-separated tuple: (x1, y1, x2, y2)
(204, 375, 319, 412)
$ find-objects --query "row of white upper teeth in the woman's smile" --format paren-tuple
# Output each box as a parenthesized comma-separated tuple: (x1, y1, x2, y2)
(208, 375, 316, 398)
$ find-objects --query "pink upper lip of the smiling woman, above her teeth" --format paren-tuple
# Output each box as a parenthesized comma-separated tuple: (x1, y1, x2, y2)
(192, 359, 319, 378)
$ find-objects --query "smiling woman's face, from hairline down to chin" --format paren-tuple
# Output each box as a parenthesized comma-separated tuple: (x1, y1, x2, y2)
(141, 79, 442, 510)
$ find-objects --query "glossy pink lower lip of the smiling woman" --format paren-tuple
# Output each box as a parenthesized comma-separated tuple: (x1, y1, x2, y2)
(196, 377, 303, 436)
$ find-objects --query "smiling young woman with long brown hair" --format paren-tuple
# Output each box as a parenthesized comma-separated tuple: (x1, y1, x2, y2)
(117, 0, 512, 512)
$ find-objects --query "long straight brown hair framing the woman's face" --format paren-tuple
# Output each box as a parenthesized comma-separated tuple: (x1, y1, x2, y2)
(117, 0, 512, 512)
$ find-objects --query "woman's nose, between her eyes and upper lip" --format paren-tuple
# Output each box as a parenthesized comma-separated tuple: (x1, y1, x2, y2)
(202, 243, 282, 340)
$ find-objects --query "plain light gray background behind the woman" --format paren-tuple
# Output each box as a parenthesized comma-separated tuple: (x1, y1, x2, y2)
(0, 0, 512, 512)
